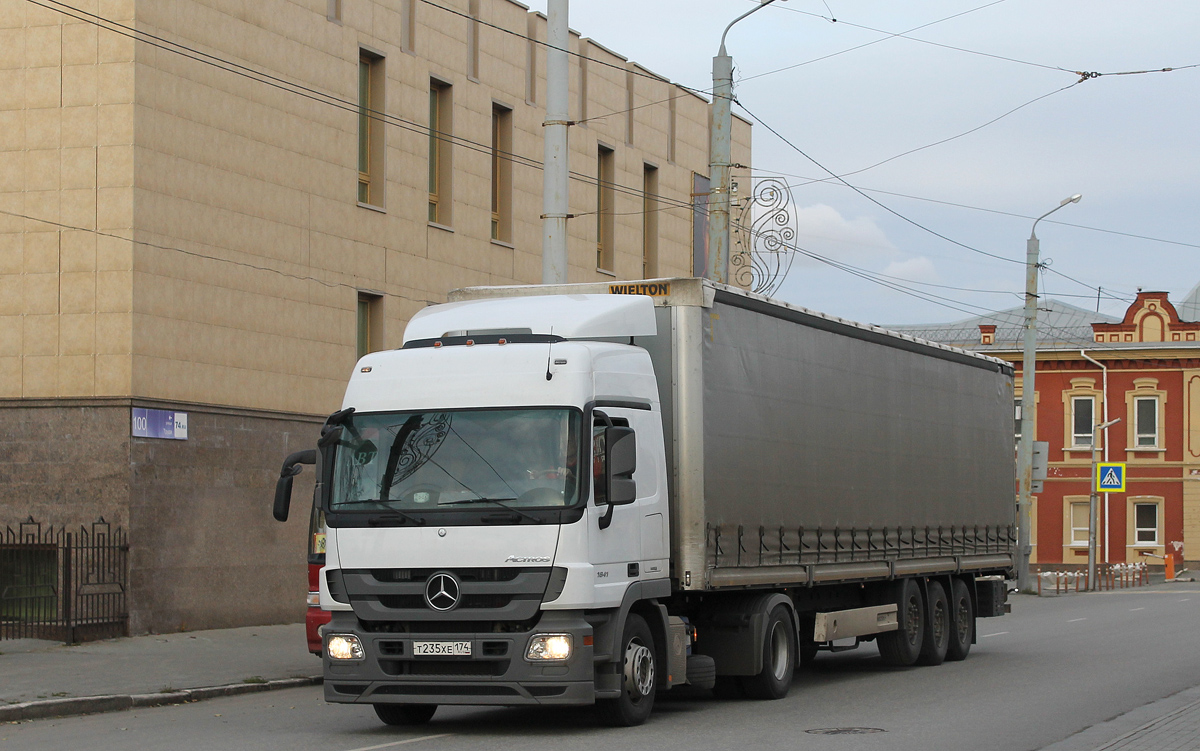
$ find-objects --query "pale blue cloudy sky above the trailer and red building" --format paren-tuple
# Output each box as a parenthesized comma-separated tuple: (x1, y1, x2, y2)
(527, 0, 1200, 324)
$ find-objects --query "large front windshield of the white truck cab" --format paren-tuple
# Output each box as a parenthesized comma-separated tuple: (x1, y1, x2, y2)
(329, 408, 581, 512)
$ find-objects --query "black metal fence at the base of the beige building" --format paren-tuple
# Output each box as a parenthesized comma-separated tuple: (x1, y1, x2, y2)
(0, 517, 130, 644)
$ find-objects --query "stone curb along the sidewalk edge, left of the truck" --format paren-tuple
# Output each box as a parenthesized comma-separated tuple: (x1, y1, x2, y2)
(0, 675, 324, 722)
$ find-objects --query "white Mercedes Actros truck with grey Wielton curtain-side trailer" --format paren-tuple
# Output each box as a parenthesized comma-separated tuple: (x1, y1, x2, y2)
(275, 278, 1015, 726)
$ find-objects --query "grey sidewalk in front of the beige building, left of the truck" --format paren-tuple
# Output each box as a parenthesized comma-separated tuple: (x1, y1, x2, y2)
(0, 624, 320, 722)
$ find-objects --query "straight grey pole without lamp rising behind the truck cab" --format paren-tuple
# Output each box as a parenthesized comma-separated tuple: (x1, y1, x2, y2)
(541, 0, 570, 284)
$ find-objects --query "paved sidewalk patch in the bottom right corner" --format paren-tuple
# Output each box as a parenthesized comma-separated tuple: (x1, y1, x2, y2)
(1040, 686, 1200, 751)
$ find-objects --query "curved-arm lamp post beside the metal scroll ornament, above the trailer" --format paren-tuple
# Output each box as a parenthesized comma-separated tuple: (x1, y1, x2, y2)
(704, 0, 775, 284)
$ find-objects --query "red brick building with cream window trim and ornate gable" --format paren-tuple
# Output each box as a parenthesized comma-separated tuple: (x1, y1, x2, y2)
(900, 286, 1200, 567)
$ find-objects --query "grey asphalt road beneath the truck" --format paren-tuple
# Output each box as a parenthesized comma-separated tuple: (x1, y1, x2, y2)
(0, 583, 1200, 751)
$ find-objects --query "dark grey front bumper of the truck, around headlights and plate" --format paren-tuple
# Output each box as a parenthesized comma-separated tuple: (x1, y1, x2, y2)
(322, 611, 595, 707)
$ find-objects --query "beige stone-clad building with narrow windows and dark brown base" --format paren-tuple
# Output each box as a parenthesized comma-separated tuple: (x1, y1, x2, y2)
(0, 0, 750, 631)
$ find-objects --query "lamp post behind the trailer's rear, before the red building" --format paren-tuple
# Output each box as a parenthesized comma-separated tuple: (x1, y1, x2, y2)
(1016, 193, 1082, 591)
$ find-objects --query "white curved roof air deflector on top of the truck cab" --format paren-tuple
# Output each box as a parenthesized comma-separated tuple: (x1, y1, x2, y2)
(404, 295, 658, 344)
